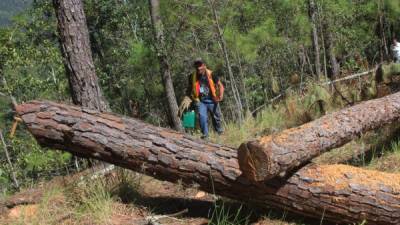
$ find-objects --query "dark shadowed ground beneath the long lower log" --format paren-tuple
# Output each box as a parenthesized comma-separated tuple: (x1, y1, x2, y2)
(114, 180, 334, 225)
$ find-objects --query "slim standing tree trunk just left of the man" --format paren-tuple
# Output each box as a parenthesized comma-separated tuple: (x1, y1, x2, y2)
(149, 0, 183, 131)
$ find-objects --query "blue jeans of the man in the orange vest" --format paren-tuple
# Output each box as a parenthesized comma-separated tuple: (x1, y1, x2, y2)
(196, 99, 223, 137)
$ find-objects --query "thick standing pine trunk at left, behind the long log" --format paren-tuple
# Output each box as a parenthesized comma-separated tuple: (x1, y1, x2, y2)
(53, 0, 109, 111)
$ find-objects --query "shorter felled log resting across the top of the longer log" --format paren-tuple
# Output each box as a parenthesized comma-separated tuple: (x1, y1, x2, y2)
(238, 90, 400, 182)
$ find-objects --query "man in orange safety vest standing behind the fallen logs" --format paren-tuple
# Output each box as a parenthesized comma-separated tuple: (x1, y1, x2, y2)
(179, 58, 224, 139)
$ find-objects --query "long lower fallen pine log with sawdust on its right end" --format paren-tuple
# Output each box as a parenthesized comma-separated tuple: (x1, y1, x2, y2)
(16, 101, 400, 224)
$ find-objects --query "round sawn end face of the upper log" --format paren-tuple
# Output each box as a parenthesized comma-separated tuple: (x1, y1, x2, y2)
(238, 141, 270, 182)
